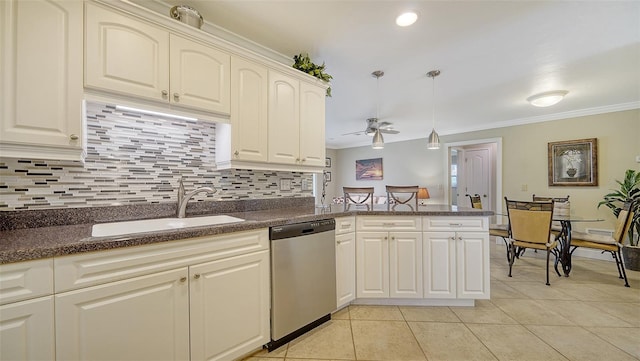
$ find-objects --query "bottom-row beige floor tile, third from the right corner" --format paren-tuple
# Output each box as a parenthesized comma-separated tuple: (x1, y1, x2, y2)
(467, 324, 566, 361)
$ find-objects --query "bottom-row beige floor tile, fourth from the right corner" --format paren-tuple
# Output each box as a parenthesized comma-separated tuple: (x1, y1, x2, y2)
(409, 322, 496, 361)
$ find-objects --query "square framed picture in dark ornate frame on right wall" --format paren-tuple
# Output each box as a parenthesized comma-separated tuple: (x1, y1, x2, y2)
(547, 138, 598, 187)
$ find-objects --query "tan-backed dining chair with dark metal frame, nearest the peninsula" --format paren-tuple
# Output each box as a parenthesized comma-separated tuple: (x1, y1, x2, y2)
(504, 197, 560, 286)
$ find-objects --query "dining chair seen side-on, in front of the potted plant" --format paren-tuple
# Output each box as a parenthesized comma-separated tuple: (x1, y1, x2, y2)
(569, 202, 633, 287)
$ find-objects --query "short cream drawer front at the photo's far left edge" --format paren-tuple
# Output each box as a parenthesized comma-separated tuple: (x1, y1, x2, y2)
(0, 258, 53, 305)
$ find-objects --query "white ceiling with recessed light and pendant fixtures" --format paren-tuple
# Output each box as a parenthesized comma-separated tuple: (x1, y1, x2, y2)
(152, 0, 640, 148)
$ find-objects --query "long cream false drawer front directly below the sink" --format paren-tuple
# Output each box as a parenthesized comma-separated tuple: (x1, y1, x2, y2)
(55, 229, 269, 293)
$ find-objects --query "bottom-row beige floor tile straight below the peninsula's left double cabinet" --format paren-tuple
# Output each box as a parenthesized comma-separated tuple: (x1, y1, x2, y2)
(351, 320, 426, 361)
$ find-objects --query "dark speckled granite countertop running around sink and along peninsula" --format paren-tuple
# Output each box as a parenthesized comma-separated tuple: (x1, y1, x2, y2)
(0, 201, 493, 264)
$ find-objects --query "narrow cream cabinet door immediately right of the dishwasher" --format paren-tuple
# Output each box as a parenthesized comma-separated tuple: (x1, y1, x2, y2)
(336, 232, 356, 308)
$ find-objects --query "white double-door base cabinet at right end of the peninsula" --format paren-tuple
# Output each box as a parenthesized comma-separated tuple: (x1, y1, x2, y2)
(423, 232, 490, 299)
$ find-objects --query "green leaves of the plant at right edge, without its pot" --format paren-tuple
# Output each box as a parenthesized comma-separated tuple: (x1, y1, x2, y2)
(598, 169, 640, 246)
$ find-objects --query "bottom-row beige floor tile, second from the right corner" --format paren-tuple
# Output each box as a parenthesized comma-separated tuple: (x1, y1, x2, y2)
(527, 326, 635, 361)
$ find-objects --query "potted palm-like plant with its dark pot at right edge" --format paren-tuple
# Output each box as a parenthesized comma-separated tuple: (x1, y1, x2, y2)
(598, 169, 640, 271)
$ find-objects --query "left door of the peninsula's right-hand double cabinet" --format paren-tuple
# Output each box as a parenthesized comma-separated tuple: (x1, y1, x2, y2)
(423, 232, 456, 298)
